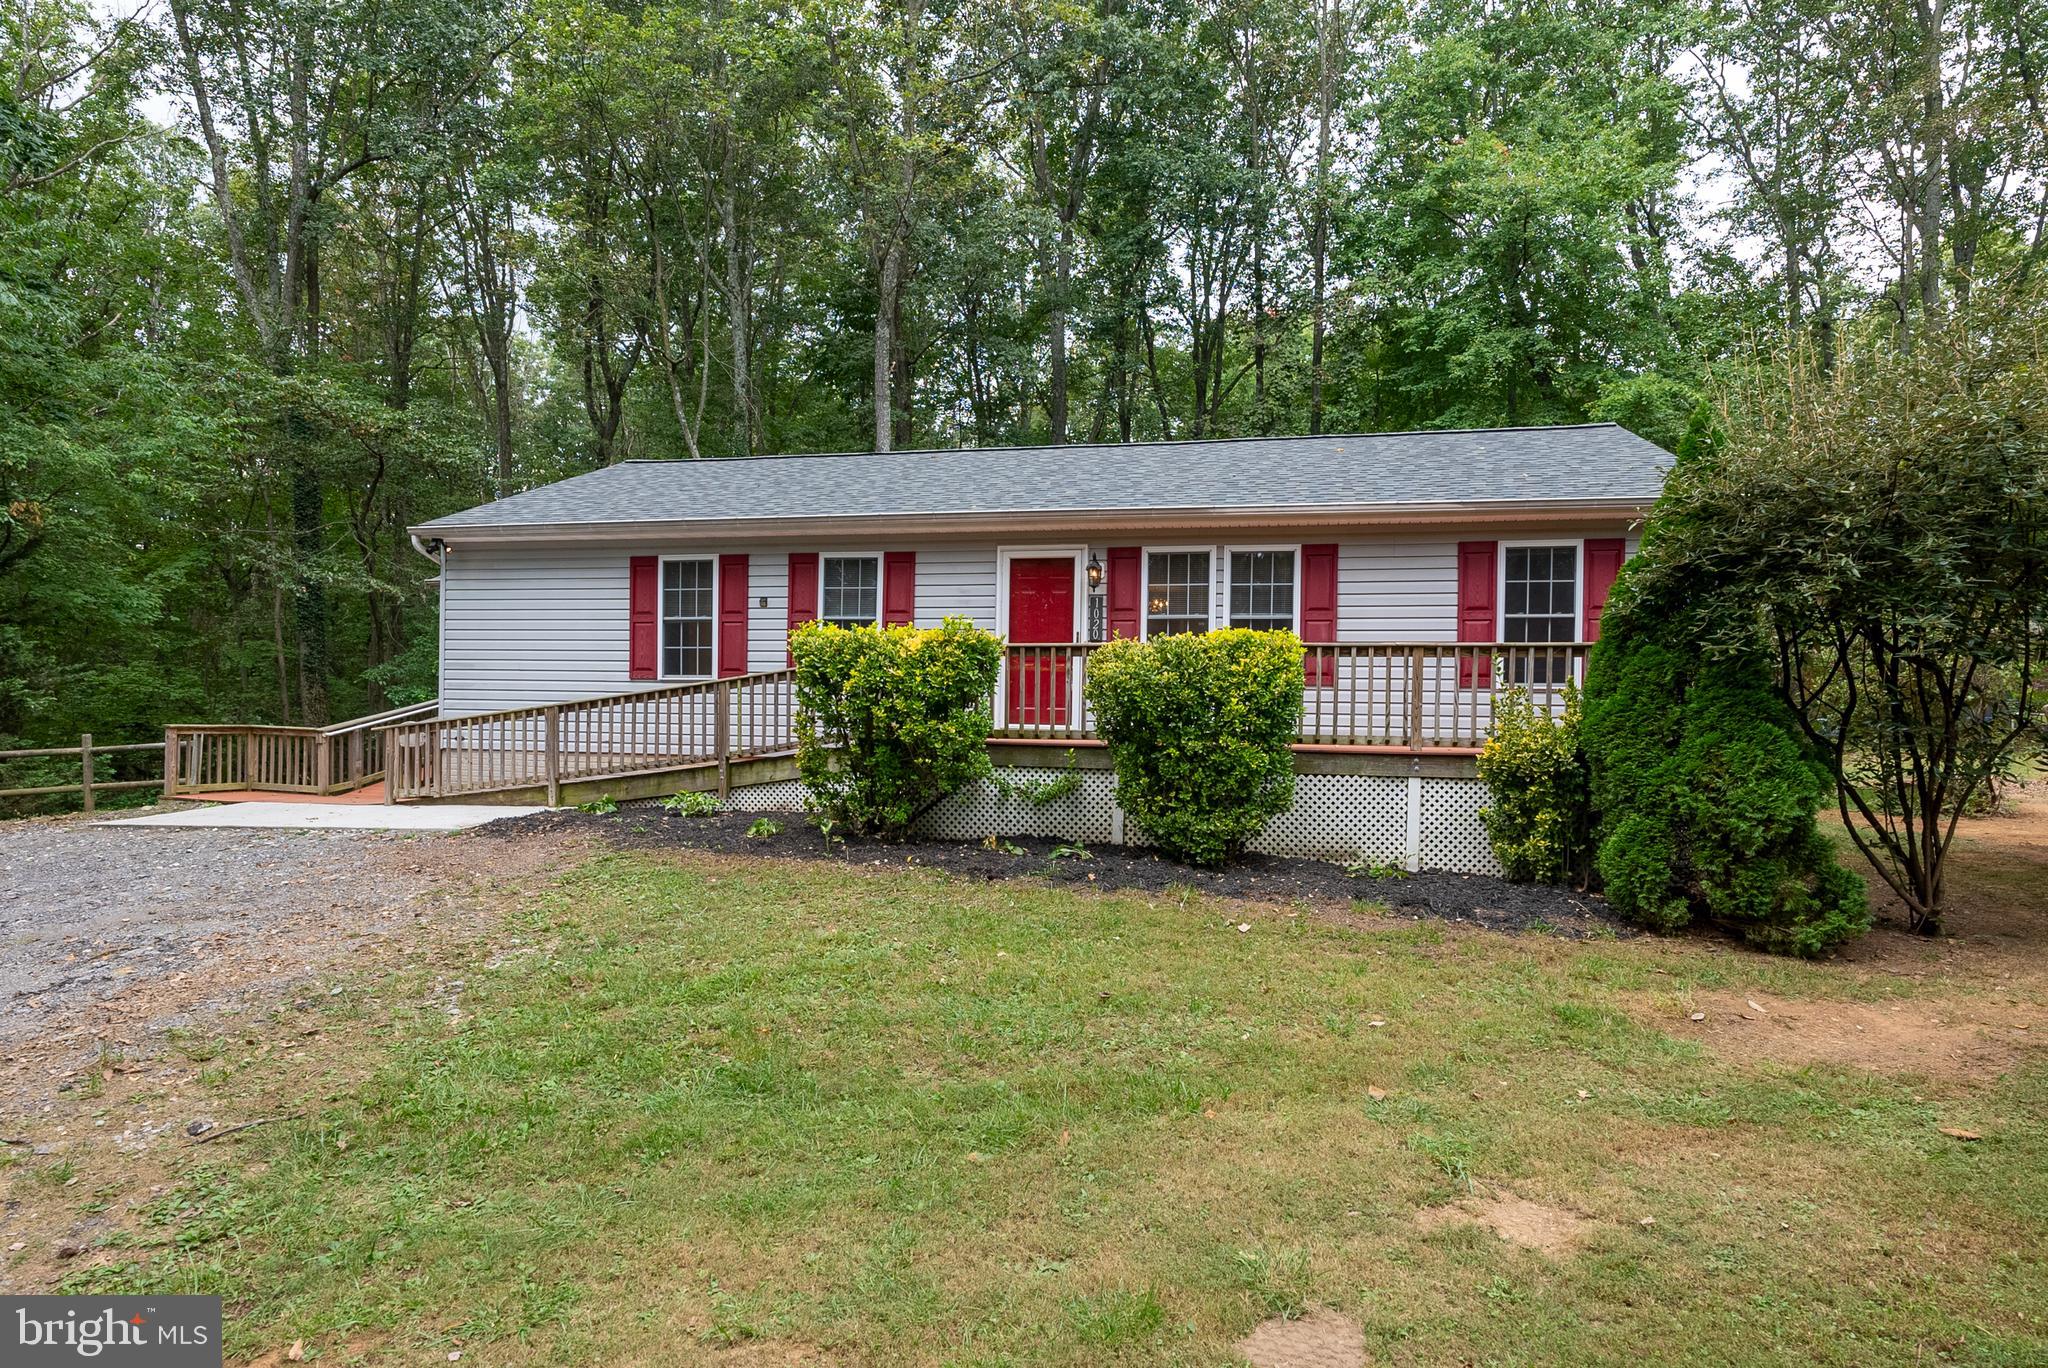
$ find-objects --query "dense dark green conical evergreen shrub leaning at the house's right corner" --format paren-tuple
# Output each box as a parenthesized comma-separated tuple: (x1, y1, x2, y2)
(1579, 571, 1870, 954)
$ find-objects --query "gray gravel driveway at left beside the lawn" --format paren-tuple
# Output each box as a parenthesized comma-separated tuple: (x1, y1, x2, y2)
(0, 819, 577, 1114)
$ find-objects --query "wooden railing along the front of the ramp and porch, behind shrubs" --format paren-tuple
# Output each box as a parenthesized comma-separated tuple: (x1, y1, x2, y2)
(383, 641, 1587, 805)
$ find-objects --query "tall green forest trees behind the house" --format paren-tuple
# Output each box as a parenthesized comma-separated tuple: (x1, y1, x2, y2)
(0, 0, 2048, 747)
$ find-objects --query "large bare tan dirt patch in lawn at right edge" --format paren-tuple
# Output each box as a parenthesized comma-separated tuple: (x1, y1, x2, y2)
(1657, 993, 2048, 1083)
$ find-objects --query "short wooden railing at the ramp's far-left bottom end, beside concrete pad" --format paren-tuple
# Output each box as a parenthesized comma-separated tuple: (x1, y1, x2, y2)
(164, 698, 440, 799)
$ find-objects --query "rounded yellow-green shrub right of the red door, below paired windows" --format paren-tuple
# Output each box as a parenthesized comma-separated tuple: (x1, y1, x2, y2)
(1087, 629, 1303, 864)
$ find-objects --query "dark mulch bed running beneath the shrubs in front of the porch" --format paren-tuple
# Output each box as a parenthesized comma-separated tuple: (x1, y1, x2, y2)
(477, 803, 1634, 940)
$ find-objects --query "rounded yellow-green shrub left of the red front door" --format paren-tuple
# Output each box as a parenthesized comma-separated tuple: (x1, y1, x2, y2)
(791, 618, 1004, 838)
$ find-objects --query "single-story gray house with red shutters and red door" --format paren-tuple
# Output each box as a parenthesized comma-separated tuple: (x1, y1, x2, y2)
(393, 424, 1669, 864)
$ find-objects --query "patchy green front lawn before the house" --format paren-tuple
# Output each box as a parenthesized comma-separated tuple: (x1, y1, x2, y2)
(32, 856, 2048, 1366)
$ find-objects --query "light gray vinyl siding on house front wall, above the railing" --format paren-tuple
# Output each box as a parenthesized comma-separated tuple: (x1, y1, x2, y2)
(440, 528, 1636, 717)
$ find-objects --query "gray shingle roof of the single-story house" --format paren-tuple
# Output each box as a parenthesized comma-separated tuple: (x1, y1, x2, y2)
(416, 424, 1671, 535)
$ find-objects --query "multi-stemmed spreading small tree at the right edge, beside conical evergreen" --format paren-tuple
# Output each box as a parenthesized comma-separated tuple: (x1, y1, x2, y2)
(1636, 287, 2048, 930)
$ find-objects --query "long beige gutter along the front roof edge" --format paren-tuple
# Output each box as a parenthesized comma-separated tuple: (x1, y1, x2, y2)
(412, 498, 1655, 547)
